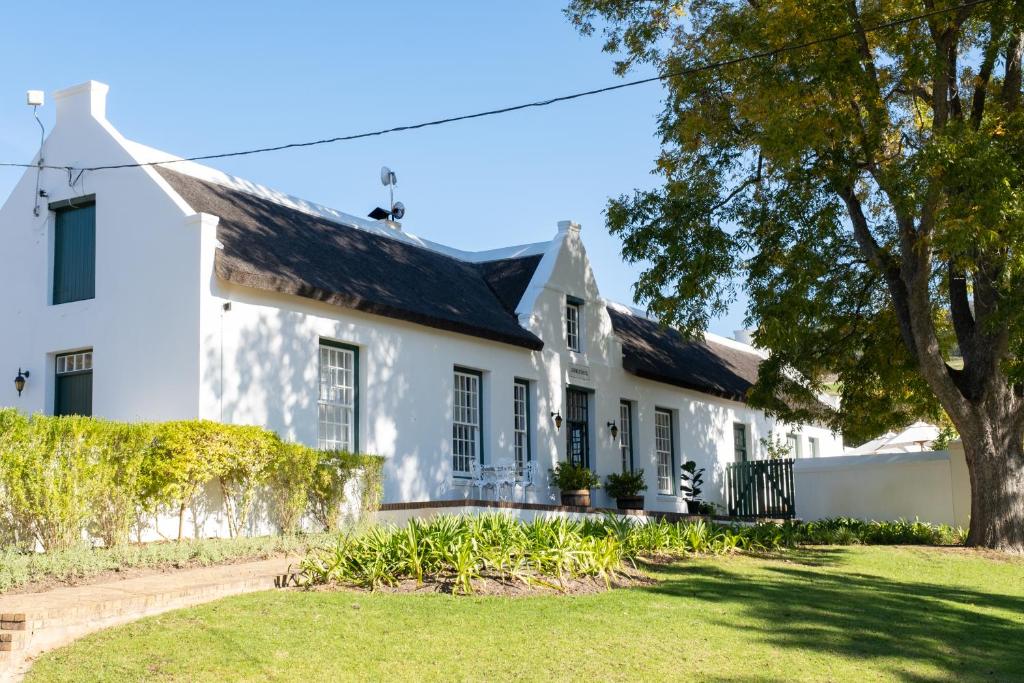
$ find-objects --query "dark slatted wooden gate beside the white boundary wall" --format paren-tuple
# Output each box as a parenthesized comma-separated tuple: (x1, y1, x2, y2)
(725, 458, 797, 519)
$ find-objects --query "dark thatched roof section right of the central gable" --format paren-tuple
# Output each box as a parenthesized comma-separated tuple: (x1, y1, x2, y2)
(607, 306, 763, 401)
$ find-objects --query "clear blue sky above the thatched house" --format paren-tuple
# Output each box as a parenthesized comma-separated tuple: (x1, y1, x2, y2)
(0, 0, 742, 335)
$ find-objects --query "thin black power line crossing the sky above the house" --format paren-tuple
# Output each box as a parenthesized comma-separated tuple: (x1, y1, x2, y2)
(0, 0, 994, 171)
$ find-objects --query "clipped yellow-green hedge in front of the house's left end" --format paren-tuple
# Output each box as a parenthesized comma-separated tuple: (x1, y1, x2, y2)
(0, 409, 383, 551)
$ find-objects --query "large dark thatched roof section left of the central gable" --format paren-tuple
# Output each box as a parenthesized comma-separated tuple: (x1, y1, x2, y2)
(157, 167, 544, 349)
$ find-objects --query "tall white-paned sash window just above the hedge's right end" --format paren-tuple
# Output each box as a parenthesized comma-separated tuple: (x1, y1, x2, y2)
(317, 339, 359, 451)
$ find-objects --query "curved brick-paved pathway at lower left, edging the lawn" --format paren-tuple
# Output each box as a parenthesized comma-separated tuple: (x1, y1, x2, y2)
(0, 557, 298, 683)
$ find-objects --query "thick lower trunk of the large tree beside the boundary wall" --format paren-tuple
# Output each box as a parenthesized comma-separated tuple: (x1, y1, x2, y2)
(961, 416, 1024, 553)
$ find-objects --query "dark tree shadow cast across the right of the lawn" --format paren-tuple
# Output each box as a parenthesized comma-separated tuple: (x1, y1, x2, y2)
(640, 550, 1024, 681)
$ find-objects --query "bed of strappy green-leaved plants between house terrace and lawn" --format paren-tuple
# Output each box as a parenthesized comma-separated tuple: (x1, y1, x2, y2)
(301, 514, 964, 594)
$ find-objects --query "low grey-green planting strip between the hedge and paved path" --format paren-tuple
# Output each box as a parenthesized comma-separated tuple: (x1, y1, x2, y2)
(0, 533, 330, 594)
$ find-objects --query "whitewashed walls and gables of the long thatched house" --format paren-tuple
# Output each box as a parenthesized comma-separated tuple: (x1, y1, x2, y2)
(0, 82, 843, 518)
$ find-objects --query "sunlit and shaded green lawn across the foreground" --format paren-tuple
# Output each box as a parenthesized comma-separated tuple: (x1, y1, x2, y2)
(22, 547, 1024, 682)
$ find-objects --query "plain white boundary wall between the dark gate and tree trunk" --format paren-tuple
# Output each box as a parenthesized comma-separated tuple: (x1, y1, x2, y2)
(793, 442, 971, 527)
